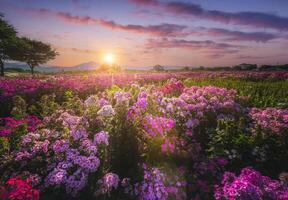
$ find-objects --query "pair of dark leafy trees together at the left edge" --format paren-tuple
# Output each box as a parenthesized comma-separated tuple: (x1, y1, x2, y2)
(0, 14, 58, 76)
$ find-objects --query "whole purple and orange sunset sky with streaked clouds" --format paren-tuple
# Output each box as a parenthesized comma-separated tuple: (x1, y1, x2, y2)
(0, 0, 288, 68)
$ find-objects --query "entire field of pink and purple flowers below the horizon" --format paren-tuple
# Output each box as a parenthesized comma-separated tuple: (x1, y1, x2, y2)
(0, 72, 288, 200)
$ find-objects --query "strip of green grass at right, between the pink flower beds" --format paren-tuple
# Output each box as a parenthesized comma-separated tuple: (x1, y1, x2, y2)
(184, 78, 288, 108)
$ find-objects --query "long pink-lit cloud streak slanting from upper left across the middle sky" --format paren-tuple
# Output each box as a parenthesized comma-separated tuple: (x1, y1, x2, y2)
(12, 6, 280, 43)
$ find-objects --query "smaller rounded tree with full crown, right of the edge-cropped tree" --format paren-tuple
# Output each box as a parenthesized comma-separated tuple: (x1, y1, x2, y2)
(17, 37, 58, 75)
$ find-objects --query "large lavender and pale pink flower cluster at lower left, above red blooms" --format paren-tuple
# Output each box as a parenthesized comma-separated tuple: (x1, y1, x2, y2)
(15, 123, 108, 195)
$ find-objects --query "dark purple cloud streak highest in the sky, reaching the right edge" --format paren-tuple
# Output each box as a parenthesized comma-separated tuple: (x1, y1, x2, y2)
(130, 0, 288, 31)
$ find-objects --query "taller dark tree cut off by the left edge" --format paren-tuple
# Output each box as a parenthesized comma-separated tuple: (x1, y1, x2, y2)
(0, 14, 17, 76)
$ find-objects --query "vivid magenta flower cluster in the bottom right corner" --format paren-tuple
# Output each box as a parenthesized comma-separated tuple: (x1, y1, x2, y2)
(214, 167, 288, 200)
